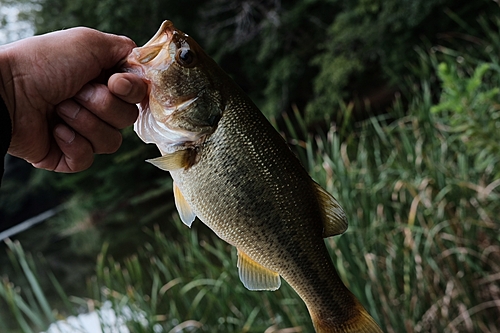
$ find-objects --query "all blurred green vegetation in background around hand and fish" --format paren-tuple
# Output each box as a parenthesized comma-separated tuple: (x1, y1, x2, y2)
(0, 0, 500, 333)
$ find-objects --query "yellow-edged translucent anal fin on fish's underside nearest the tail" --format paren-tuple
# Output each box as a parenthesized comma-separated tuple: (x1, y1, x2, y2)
(238, 249, 281, 291)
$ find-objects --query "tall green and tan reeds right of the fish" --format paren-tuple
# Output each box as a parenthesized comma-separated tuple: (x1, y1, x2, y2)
(296, 87, 500, 332)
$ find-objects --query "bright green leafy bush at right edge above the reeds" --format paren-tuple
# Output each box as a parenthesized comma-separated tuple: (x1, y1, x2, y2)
(431, 63, 500, 178)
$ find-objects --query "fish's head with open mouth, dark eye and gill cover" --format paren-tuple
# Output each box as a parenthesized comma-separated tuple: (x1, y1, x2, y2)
(124, 21, 224, 153)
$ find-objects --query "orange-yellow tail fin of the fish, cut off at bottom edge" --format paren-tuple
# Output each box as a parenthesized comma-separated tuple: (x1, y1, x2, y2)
(312, 305, 383, 333)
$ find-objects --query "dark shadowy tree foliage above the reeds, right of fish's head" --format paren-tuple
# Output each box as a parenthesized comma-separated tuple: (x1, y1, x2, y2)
(200, 0, 500, 124)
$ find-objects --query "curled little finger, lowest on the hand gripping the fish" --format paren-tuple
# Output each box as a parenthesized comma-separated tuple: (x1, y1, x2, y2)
(32, 124, 94, 173)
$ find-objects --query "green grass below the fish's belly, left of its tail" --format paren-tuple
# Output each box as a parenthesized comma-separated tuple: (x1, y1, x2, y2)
(89, 219, 308, 332)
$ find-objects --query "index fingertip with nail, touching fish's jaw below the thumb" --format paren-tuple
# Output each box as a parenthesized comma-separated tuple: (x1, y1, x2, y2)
(108, 73, 148, 104)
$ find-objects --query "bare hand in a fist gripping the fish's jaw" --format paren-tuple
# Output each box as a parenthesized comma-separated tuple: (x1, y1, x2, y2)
(0, 27, 147, 172)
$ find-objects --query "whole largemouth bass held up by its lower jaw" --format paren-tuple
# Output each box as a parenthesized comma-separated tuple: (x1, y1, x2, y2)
(125, 20, 382, 333)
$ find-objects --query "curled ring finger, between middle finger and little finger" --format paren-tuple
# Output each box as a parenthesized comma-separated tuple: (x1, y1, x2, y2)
(56, 99, 122, 154)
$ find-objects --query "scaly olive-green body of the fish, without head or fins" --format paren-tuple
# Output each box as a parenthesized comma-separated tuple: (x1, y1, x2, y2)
(170, 95, 372, 330)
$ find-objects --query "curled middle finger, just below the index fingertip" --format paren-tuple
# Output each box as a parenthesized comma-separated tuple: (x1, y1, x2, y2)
(74, 83, 139, 129)
